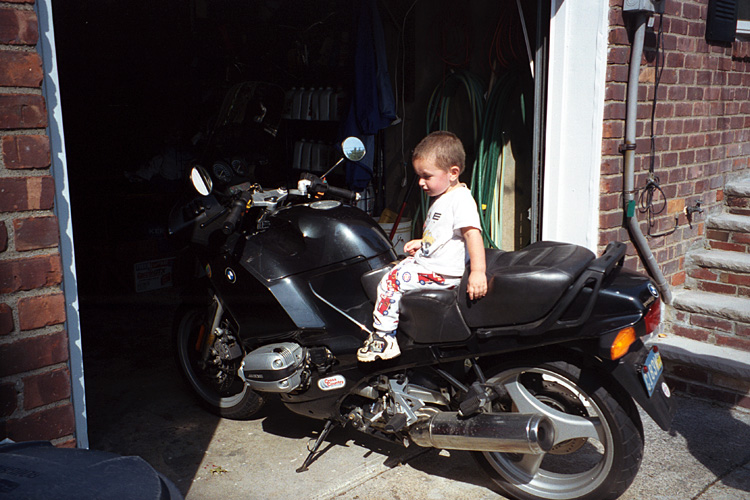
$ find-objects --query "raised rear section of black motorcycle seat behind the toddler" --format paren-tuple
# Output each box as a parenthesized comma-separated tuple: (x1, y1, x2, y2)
(458, 241, 595, 328)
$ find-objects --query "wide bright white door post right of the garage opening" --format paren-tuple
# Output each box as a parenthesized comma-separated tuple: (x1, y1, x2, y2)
(542, 0, 609, 251)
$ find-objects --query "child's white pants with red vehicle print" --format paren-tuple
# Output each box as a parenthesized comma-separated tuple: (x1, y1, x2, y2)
(372, 257, 461, 333)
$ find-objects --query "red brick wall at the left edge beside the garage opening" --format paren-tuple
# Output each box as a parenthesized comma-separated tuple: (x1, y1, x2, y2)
(0, 0, 75, 446)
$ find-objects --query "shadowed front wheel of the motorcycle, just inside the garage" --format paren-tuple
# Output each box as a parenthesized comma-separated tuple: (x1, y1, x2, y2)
(175, 307, 264, 420)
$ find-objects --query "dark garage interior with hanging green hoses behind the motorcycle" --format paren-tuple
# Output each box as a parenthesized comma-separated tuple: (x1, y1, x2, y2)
(53, 0, 550, 470)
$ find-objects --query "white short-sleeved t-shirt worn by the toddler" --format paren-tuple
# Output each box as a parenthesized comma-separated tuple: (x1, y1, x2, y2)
(414, 184, 481, 276)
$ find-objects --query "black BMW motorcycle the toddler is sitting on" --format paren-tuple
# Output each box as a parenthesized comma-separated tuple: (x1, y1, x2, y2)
(170, 140, 674, 500)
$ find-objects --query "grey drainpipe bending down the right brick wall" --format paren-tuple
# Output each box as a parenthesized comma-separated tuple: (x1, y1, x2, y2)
(622, 11, 672, 304)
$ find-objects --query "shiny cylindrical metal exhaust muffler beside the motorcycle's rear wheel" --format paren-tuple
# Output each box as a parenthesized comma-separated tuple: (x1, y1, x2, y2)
(409, 412, 555, 455)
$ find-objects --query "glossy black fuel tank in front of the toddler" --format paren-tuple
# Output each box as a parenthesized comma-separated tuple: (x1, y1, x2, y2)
(241, 200, 395, 281)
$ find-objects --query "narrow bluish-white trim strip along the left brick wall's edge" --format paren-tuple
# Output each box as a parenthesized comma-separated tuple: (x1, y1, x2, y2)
(36, 0, 89, 448)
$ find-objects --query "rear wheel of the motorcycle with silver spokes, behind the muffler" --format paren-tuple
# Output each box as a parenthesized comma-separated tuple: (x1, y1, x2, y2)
(474, 361, 643, 500)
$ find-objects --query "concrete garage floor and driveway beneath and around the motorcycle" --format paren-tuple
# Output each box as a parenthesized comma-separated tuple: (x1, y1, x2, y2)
(82, 293, 750, 500)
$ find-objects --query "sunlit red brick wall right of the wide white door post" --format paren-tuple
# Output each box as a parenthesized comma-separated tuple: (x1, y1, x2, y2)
(599, 0, 750, 278)
